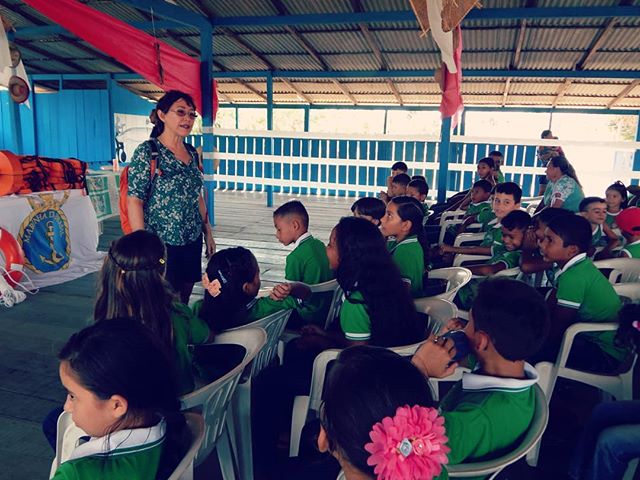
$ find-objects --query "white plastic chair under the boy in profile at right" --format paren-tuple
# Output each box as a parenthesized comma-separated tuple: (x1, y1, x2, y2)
(527, 322, 638, 467)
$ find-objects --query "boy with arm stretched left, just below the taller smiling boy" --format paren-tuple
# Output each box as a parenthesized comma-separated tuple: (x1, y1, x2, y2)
(454, 210, 531, 310)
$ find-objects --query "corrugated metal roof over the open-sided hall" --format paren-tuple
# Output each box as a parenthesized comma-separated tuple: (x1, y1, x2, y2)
(0, 0, 640, 109)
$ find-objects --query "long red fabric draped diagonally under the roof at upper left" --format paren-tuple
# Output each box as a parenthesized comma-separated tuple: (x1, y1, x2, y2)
(25, 0, 218, 117)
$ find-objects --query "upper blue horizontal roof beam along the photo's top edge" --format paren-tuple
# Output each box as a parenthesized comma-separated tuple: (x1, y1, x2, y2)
(210, 7, 640, 27)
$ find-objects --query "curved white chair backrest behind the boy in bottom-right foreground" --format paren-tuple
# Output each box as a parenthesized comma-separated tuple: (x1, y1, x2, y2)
(447, 385, 549, 478)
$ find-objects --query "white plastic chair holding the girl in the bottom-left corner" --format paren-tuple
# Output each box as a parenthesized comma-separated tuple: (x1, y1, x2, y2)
(49, 412, 204, 480)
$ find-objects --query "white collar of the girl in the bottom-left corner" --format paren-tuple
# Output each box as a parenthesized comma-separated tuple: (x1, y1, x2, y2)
(69, 418, 167, 460)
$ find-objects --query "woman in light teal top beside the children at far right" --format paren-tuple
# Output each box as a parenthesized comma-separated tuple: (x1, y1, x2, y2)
(536, 157, 584, 213)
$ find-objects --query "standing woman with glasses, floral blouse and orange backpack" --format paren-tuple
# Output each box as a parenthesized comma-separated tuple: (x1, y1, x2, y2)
(127, 90, 216, 304)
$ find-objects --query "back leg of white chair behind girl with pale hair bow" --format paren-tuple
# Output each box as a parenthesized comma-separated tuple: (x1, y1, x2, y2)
(227, 380, 253, 480)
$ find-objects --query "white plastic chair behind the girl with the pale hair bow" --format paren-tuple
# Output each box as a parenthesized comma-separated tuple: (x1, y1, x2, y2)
(226, 310, 293, 479)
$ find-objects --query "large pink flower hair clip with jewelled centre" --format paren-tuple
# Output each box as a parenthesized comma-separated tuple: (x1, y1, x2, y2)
(364, 405, 450, 480)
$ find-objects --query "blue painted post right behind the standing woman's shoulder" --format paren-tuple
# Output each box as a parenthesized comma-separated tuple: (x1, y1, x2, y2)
(200, 26, 216, 225)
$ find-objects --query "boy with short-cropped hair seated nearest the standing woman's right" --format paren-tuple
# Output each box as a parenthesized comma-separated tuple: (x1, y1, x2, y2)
(273, 200, 333, 327)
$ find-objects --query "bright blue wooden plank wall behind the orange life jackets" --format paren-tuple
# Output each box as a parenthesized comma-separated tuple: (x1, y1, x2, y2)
(0, 84, 153, 164)
